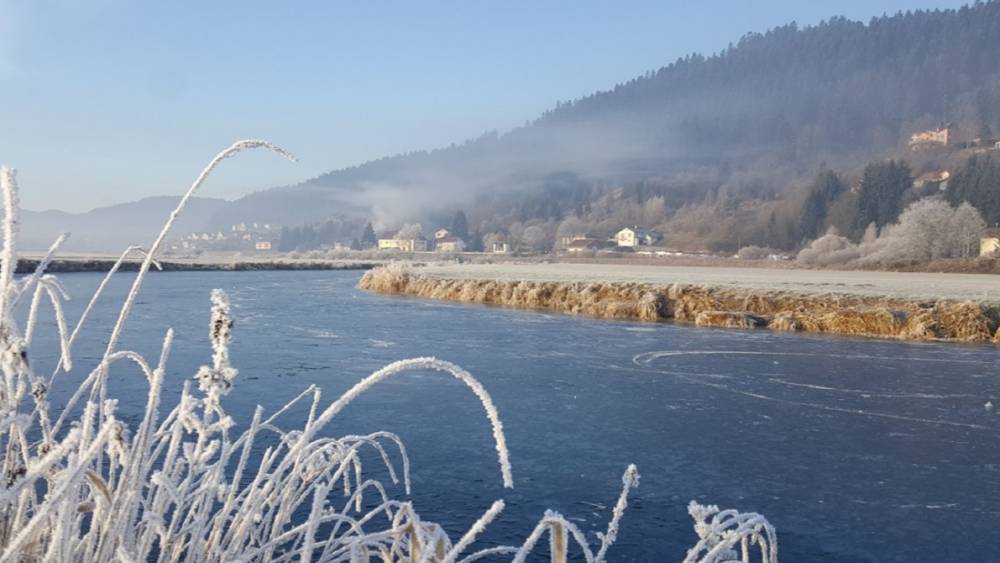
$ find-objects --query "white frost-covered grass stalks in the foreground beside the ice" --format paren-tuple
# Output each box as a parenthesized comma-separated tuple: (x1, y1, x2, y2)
(0, 140, 777, 563)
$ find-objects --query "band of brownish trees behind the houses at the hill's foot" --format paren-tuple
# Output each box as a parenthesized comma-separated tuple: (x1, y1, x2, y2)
(456, 151, 1000, 252)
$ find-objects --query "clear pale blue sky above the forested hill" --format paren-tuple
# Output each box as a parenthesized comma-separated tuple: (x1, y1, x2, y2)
(0, 0, 976, 211)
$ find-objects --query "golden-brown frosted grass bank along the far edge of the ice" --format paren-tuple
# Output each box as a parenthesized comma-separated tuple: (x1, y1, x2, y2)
(359, 266, 1000, 343)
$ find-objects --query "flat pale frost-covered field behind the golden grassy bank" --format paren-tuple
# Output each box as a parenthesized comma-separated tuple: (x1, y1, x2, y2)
(420, 263, 1000, 303)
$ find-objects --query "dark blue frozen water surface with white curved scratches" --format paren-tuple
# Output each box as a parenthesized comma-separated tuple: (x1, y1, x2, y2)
(34, 271, 1000, 562)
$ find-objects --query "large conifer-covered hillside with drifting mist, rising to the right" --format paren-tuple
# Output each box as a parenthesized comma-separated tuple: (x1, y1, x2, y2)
(217, 1, 1000, 236)
